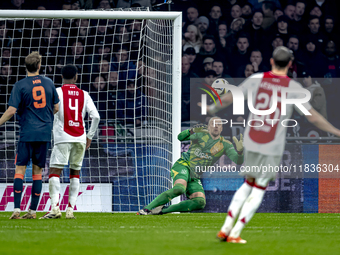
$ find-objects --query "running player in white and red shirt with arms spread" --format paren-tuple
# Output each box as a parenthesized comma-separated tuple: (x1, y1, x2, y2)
(208, 46, 340, 243)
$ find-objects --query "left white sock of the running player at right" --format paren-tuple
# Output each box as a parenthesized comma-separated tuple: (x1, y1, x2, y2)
(221, 180, 254, 235)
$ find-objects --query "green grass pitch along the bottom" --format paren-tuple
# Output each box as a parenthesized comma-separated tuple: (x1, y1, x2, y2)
(0, 213, 340, 255)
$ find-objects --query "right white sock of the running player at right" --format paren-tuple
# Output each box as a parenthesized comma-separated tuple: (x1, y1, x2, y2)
(229, 187, 266, 238)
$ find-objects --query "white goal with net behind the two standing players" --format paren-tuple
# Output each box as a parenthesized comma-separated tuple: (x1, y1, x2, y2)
(0, 9, 181, 212)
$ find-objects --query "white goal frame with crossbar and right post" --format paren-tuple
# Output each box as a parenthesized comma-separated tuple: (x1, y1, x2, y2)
(0, 10, 182, 204)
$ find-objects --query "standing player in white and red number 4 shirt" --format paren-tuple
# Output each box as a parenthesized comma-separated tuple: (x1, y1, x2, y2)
(40, 65, 100, 219)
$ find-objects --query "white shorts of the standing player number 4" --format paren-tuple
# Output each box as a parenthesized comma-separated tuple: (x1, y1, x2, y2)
(50, 143, 86, 170)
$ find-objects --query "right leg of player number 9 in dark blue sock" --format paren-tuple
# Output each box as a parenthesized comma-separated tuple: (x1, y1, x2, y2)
(22, 142, 50, 219)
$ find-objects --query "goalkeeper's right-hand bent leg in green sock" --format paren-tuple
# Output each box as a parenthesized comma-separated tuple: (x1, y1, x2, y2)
(162, 178, 206, 214)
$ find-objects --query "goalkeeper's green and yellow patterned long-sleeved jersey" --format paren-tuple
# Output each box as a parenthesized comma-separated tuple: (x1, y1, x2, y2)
(178, 129, 243, 177)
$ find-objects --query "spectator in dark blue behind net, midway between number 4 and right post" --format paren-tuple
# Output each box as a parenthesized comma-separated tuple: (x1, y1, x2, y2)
(117, 80, 147, 126)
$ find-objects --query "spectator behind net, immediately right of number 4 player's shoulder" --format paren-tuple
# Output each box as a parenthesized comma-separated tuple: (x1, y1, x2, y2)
(89, 76, 116, 121)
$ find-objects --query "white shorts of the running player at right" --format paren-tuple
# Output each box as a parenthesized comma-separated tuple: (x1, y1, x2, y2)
(240, 150, 282, 187)
